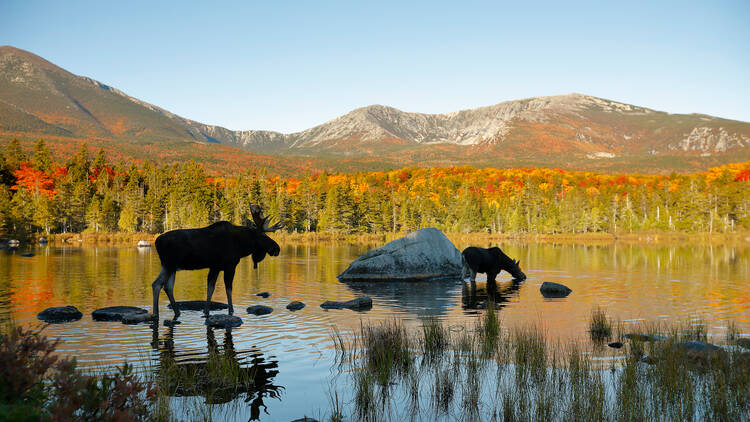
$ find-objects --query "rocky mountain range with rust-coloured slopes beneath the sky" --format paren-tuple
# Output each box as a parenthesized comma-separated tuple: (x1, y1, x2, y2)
(0, 46, 750, 172)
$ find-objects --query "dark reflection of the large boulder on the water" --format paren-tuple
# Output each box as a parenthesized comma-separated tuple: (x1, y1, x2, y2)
(343, 279, 468, 316)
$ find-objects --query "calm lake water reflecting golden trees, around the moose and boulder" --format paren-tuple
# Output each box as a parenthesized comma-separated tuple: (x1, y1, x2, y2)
(0, 239, 750, 421)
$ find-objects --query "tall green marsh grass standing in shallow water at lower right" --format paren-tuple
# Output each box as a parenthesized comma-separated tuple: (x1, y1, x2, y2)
(328, 316, 750, 421)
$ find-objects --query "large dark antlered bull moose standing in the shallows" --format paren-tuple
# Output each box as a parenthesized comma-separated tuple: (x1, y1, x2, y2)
(151, 205, 282, 318)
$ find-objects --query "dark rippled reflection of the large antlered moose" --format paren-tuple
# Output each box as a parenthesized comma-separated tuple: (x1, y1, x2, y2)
(151, 326, 284, 420)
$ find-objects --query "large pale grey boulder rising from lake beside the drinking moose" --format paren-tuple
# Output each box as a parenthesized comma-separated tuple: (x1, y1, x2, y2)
(338, 227, 462, 281)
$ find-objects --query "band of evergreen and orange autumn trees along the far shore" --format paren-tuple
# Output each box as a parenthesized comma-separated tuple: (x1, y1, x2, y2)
(0, 139, 750, 236)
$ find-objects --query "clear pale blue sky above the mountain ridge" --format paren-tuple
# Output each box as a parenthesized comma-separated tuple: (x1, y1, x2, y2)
(0, 0, 750, 132)
